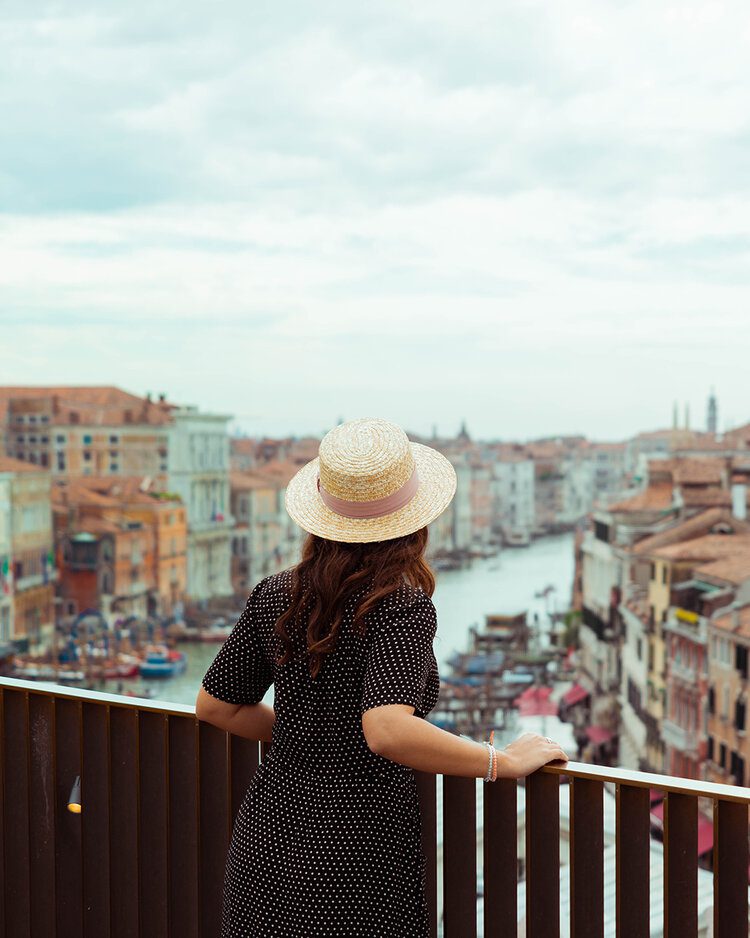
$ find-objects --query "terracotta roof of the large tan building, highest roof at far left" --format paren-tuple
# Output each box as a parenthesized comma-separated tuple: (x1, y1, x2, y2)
(0, 385, 177, 426)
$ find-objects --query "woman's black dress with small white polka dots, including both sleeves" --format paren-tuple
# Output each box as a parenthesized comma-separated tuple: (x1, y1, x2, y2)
(202, 570, 440, 938)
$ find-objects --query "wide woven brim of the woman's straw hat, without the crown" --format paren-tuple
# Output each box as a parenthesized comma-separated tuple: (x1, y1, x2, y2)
(284, 441, 457, 544)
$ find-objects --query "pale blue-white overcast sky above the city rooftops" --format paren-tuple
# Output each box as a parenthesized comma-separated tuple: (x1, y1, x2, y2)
(0, 0, 750, 439)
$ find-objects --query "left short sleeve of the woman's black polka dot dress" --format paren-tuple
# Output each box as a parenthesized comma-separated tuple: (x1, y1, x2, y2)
(201, 580, 273, 704)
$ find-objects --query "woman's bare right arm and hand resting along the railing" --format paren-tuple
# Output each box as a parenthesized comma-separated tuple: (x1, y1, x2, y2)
(362, 704, 568, 778)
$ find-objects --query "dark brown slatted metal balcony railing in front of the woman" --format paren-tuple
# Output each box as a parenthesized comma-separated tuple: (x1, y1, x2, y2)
(0, 678, 750, 938)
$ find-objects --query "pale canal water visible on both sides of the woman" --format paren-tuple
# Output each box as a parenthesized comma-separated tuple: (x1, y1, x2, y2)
(128, 534, 574, 704)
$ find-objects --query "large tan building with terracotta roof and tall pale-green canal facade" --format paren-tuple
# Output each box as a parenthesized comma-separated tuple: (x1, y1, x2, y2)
(0, 387, 231, 600)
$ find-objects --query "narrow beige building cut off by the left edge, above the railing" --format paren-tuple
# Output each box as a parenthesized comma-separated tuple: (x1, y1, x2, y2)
(0, 456, 57, 651)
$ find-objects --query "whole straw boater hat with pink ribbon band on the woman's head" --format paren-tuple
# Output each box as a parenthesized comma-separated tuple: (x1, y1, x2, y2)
(285, 417, 457, 543)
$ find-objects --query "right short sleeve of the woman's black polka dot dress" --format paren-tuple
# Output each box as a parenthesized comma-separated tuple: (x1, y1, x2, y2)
(361, 591, 437, 716)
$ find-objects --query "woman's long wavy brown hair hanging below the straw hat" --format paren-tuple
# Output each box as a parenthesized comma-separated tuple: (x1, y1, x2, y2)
(275, 527, 435, 678)
